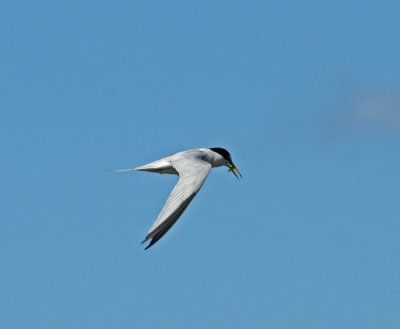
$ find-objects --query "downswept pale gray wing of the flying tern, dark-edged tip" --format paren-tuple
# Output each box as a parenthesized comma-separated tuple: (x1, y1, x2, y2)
(142, 158, 211, 249)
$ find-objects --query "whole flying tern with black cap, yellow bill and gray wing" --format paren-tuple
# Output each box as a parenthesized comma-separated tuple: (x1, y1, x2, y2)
(111, 147, 242, 250)
